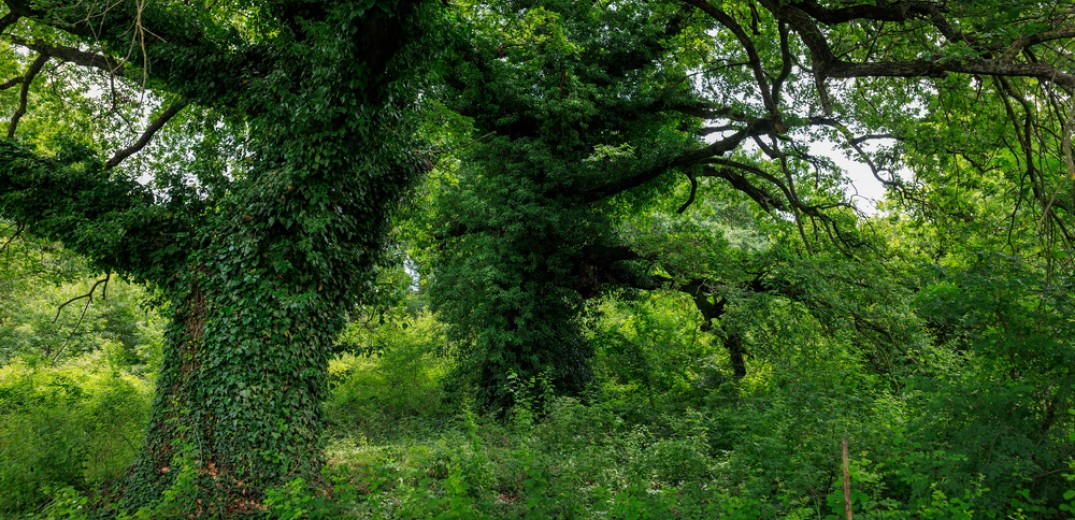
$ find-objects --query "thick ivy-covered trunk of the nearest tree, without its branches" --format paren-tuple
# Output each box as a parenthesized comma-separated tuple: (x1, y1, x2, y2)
(127, 96, 421, 507)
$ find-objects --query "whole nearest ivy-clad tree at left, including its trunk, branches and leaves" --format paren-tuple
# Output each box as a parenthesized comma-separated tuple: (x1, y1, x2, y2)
(0, 0, 442, 516)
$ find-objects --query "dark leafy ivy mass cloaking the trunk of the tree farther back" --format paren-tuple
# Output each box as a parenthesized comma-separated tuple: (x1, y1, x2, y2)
(430, 1, 700, 408)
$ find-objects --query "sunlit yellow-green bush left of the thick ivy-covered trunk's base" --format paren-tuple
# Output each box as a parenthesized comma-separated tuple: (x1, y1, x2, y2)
(0, 352, 152, 515)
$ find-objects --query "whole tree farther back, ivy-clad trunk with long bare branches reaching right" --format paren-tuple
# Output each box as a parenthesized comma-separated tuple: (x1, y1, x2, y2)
(423, 0, 1075, 404)
